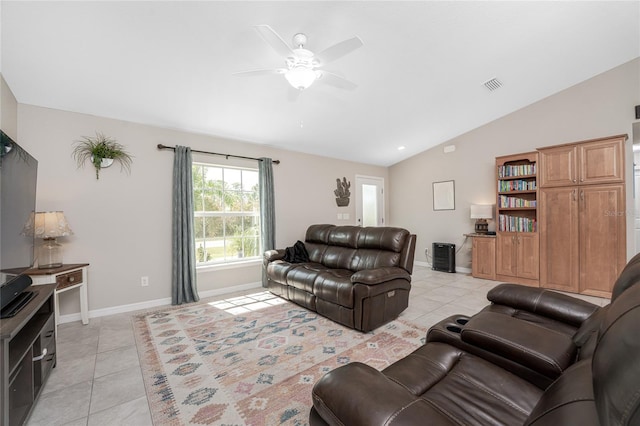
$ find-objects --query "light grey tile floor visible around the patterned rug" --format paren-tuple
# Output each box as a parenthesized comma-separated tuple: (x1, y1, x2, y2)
(27, 266, 609, 426)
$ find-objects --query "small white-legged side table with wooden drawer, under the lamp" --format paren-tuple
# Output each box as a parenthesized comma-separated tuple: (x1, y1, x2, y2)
(26, 263, 89, 335)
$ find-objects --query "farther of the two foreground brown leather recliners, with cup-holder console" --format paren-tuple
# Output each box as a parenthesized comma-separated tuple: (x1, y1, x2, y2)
(427, 255, 640, 389)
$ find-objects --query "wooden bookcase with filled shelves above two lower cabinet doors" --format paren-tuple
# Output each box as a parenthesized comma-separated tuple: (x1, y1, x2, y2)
(496, 152, 539, 287)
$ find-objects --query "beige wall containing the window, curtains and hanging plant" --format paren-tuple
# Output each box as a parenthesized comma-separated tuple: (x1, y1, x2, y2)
(18, 104, 388, 315)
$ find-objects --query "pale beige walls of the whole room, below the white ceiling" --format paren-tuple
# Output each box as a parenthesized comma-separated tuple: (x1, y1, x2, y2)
(10, 60, 640, 315)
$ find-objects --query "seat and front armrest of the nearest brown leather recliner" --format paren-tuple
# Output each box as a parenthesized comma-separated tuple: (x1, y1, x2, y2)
(312, 343, 542, 425)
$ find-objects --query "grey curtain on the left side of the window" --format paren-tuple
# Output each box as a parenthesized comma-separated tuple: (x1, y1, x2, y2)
(171, 145, 200, 305)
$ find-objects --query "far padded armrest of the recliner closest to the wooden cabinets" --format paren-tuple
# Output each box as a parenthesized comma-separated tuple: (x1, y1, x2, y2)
(487, 284, 599, 327)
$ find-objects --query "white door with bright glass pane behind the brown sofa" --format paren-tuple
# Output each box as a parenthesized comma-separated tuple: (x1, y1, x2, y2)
(356, 176, 385, 226)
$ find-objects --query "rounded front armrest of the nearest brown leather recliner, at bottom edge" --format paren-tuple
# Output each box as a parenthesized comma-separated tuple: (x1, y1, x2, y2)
(311, 362, 417, 425)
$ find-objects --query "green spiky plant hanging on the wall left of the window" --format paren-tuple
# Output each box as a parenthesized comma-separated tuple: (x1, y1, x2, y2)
(73, 132, 133, 179)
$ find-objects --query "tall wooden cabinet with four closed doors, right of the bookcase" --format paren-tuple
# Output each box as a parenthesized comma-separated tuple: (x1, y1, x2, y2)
(539, 135, 627, 297)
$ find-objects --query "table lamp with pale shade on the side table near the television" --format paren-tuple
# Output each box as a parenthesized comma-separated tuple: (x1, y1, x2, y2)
(23, 211, 73, 269)
